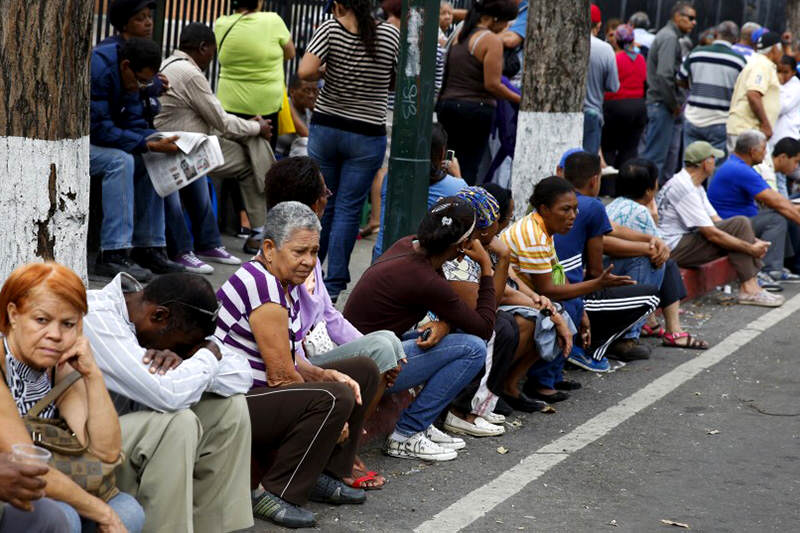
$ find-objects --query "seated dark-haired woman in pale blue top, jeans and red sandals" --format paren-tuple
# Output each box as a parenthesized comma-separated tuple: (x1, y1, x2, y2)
(606, 159, 708, 350)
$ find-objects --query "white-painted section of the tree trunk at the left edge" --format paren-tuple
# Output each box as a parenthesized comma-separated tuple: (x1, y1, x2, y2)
(0, 136, 89, 280)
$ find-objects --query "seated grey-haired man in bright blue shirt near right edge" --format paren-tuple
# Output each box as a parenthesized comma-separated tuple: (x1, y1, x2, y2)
(708, 130, 800, 282)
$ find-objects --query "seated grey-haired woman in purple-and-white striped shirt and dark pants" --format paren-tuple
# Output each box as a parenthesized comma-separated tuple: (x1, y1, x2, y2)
(215, 202, 379, 527)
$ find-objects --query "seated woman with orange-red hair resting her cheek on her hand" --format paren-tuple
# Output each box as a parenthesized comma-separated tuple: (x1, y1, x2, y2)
(0, 263, 144, 533)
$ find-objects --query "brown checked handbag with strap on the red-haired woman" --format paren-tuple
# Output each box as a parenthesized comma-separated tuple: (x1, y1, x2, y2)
(0, 343, 123, 502)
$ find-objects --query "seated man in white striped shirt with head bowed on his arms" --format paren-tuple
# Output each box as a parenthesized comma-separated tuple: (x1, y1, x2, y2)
(83, 273, 253, 533)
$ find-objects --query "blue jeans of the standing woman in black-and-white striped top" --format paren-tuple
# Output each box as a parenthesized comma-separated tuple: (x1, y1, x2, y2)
(308, 124, 386, 299)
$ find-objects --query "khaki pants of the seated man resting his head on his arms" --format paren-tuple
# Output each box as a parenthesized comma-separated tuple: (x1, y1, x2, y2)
(117, 394, 253, 533)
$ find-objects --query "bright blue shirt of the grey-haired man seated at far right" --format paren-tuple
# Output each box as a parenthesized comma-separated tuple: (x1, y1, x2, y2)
(708, 154, 769, 218)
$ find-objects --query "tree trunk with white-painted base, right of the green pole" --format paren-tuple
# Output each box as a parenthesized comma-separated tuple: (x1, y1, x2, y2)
(512, 0, 589, 216)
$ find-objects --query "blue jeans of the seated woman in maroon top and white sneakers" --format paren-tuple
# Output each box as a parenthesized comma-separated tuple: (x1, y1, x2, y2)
(389, 331, 486, 437)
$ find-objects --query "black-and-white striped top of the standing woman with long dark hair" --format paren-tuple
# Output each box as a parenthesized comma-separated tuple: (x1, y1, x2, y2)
(306, 18, 400, 136)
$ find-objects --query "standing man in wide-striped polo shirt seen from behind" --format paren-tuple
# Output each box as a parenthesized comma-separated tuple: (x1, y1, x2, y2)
(678, 20, 747, 164)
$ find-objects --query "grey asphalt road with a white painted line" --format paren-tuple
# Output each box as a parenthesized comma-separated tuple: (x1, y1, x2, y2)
(92, 234, 800, 532)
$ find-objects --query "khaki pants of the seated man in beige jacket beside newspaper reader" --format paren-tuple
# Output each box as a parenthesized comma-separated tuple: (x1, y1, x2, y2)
(209, 137, 275, 228)
